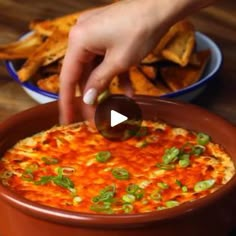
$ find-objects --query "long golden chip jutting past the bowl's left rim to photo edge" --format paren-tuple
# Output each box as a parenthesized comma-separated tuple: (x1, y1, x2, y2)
(0, 33, 44, 60)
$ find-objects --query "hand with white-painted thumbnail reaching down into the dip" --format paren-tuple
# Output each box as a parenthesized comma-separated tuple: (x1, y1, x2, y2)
(59, 0, 216, 124)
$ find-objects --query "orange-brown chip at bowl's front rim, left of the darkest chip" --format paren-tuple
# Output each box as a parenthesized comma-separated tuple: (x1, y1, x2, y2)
(129, 67, 170, 96)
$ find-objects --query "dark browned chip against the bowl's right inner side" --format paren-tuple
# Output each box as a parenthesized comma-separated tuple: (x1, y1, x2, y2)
(161, 50, 210, 91)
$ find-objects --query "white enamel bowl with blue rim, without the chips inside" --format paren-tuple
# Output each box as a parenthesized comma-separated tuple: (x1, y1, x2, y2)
(6, 32, 222, 104)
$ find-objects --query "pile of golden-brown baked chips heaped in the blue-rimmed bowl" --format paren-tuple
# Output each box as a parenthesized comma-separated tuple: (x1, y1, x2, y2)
(0, 9, 210, 96)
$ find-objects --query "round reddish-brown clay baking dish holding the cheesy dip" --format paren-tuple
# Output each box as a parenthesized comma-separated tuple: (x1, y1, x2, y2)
(0, 97, 236, 236)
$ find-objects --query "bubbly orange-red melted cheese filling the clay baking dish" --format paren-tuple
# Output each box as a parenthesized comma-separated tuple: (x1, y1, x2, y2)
(0, 121, 235, 213)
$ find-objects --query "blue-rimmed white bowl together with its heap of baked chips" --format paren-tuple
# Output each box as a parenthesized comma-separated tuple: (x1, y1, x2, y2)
(0, 12, 222, 103)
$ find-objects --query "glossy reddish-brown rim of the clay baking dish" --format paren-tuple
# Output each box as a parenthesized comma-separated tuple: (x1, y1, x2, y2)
(0, 96, 236, 228)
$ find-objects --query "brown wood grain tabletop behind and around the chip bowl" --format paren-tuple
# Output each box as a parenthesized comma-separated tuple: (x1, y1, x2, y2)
(0, 0, 236, 124)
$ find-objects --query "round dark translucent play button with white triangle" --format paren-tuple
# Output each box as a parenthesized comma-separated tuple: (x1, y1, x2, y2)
(95, 95, 142, 141)
